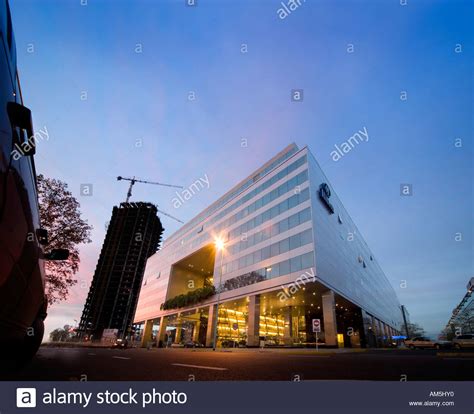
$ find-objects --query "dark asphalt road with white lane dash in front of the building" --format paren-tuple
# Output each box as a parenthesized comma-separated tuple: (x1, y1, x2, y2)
(0, 347, 474, 381)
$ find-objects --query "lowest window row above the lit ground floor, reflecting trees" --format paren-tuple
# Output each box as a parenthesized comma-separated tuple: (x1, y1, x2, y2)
(220, 252, 314, 292)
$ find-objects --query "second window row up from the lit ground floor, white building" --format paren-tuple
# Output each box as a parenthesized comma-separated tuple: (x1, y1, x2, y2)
(222, 228, 313, 274)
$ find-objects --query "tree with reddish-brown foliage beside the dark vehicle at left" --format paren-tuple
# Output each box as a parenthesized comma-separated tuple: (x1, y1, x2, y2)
(37, 174, 92, 305)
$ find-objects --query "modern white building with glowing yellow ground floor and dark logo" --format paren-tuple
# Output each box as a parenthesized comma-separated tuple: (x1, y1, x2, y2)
(134, 144, 402, 347)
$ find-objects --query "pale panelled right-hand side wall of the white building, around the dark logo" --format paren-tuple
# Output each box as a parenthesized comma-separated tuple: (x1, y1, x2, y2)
(308, 153, 402, 327)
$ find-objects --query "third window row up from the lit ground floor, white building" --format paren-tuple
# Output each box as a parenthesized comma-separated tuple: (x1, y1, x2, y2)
(227, 207, 311, 254)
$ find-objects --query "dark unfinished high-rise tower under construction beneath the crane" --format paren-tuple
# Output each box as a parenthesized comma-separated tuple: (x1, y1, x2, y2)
(78, 202, 163, 339)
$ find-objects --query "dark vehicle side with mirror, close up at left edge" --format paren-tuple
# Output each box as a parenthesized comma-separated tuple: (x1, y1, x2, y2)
(0, 0, 68, 366)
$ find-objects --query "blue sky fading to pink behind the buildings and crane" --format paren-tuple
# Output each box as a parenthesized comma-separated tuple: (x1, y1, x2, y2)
(10, 0, 474, 336)
